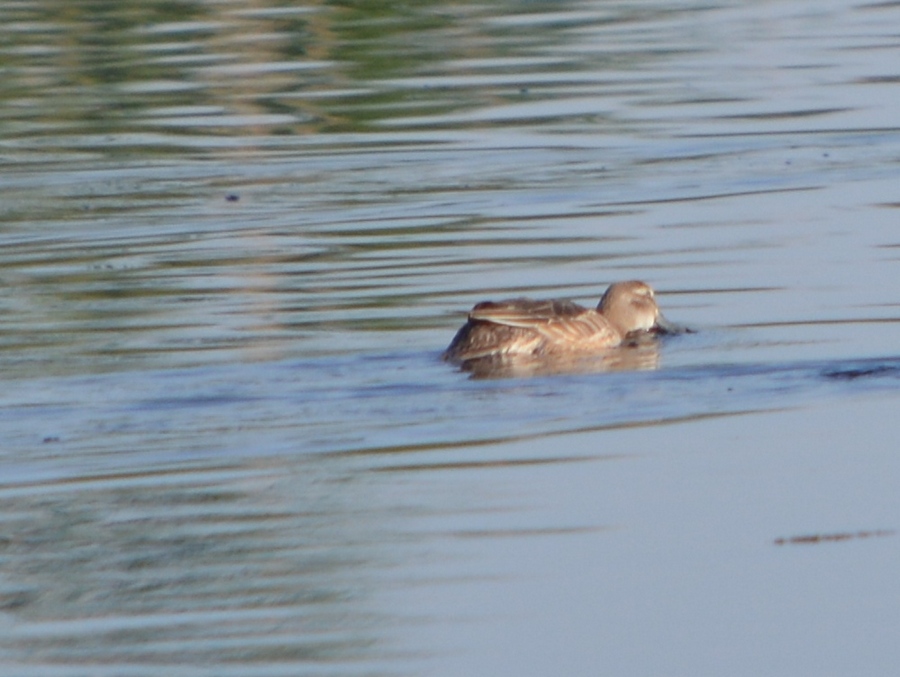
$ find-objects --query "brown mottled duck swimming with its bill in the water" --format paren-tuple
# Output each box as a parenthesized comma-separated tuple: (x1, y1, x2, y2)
(443, 280, 672, 366)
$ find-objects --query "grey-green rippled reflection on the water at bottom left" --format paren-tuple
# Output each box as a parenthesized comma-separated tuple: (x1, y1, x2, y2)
(0, 452, 432, 674)
